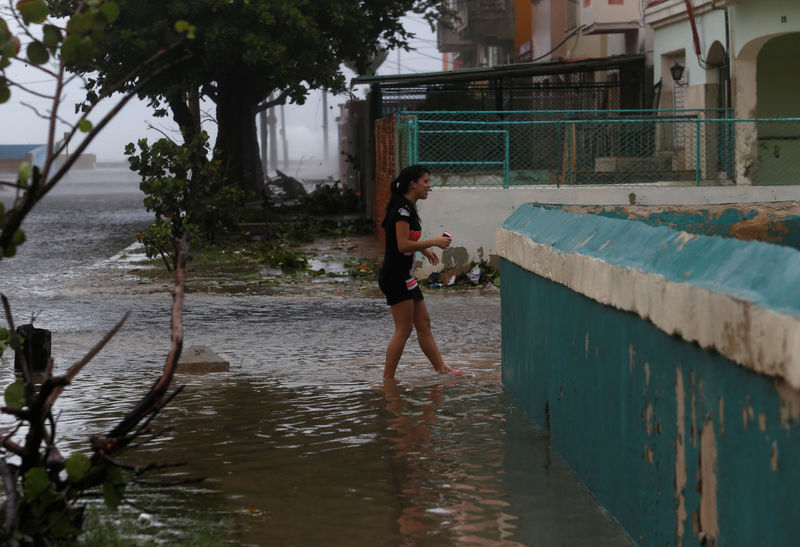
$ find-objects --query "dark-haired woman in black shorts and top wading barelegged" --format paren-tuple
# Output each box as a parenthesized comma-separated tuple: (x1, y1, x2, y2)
(378, 165, 452, 379)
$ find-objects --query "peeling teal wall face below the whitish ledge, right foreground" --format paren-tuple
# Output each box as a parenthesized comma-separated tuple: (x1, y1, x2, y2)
(501, 260, 800, 546)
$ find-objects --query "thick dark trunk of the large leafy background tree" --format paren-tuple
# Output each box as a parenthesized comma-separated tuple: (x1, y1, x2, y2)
(215, 76, 264, 198)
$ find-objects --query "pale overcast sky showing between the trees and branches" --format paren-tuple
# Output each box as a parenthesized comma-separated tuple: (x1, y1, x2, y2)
(0, 16, 442, 173)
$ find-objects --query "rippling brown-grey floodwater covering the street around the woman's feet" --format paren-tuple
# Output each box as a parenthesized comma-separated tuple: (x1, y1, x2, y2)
(0, 166, 630, 546)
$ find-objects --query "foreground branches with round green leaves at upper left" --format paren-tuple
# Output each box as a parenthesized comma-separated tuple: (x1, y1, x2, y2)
(0, 0, 191, 259)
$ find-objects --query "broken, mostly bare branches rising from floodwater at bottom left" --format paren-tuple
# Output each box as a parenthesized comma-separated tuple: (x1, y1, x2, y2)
(0, 232, 193, 544)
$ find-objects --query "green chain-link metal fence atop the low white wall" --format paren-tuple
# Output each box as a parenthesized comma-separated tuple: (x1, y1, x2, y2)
(398, 109, 800, 187)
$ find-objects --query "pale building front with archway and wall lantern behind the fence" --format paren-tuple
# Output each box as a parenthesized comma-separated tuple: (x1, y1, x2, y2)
(644, 0, 800, 185)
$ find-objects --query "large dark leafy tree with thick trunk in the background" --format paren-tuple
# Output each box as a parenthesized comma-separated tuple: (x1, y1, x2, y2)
(84, 0, 449, 196)
